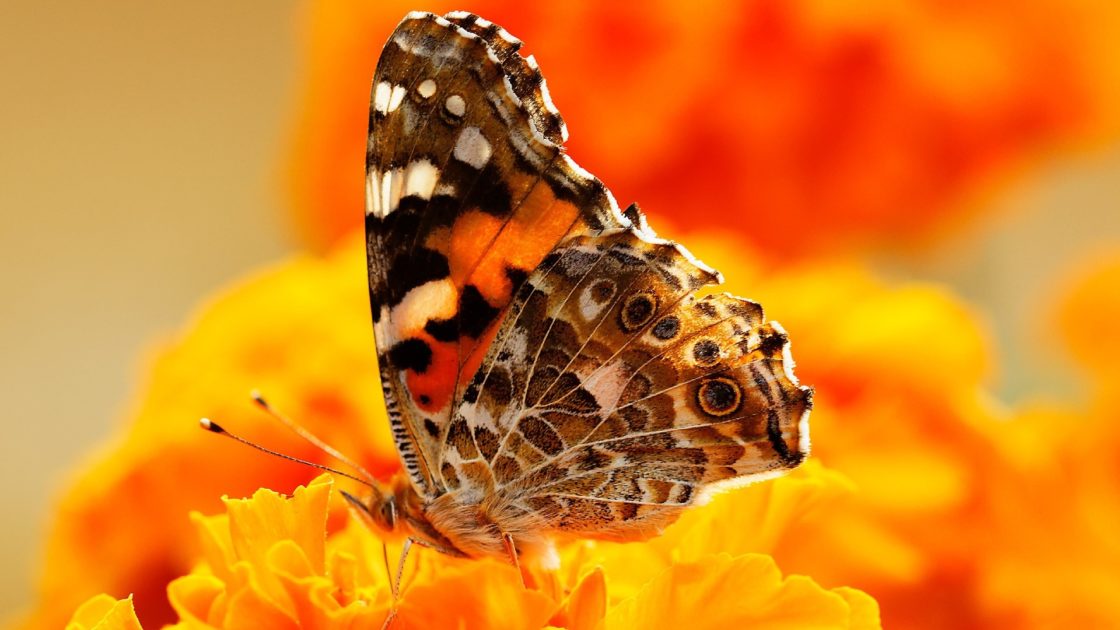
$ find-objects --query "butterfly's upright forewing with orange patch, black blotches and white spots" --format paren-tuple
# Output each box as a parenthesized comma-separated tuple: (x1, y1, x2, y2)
(365, 12, 629, 498)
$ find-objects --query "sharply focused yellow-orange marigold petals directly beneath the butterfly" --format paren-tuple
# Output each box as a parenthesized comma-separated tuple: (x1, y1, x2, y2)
(162, 466, 878, 629)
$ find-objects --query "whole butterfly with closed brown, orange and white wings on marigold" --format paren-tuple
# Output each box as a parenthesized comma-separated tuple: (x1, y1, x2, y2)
(352, 11, 812, 562)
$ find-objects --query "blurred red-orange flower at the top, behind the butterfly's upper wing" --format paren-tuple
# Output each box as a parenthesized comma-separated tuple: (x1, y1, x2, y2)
(290, 0, 1120, 256)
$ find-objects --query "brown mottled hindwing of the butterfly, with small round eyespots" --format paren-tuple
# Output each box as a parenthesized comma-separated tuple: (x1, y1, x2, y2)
(440, 227, 811, 539)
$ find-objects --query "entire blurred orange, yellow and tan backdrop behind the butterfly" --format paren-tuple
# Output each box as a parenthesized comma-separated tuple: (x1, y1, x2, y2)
(0, 0, 1120, 628)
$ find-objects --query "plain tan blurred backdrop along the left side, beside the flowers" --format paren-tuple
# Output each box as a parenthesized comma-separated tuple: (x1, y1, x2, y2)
(0, 0, 301, 611)
